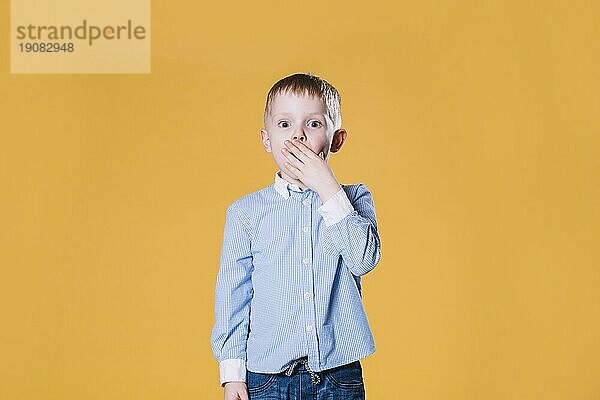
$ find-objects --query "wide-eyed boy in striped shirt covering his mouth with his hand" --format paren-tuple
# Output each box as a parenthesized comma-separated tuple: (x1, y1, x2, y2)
(211, 74, 381, 400)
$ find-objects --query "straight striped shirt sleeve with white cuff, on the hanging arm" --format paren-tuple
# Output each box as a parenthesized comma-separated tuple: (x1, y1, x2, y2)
(211, 203, 254, 385)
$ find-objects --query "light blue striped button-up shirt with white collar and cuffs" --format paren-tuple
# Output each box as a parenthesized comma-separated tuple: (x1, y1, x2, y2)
(211, 171, 381, 385)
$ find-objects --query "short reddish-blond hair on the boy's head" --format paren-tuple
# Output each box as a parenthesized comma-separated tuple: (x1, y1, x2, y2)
(264, 73, 342, 132)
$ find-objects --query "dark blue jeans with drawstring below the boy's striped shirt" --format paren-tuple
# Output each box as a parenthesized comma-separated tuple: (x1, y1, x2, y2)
(246, 357, 365, 400)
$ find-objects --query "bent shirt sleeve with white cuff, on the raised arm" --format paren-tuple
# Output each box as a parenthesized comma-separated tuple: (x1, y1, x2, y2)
(317, 183, 381, 276)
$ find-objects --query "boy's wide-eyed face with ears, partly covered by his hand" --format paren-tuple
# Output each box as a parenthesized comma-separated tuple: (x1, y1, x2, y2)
(260, 93, 346, 178)
